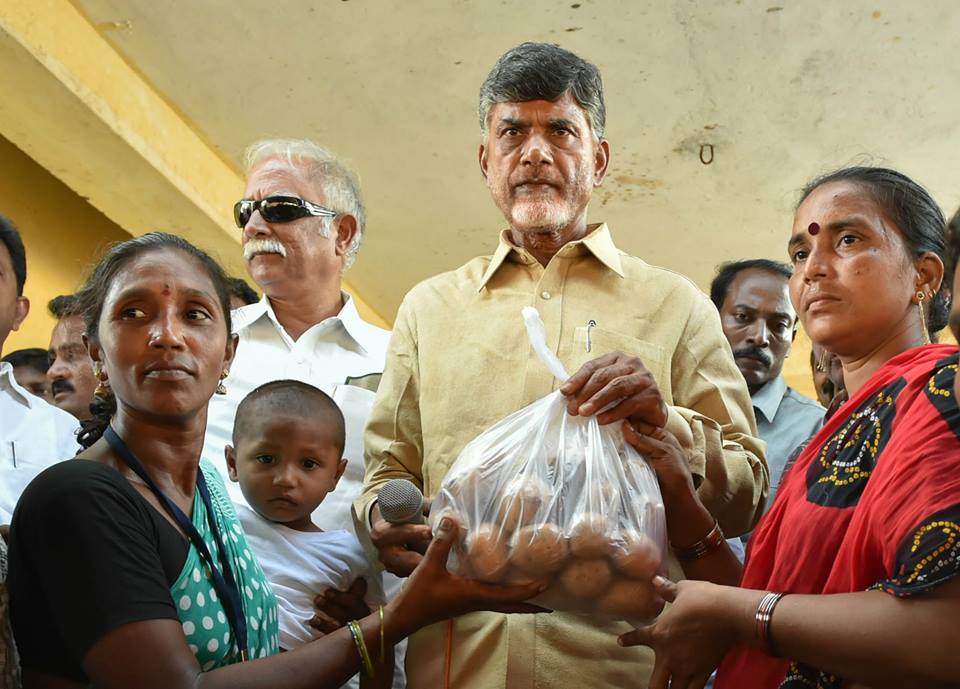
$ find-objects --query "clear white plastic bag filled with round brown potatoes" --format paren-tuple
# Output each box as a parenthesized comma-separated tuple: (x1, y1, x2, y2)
(430, 307, 666, 623)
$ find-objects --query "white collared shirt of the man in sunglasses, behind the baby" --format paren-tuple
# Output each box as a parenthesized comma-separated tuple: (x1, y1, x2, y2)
(203, 294, 390, 533)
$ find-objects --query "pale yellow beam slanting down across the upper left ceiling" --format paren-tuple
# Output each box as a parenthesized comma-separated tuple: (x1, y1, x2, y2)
(0, 0, 386, 330)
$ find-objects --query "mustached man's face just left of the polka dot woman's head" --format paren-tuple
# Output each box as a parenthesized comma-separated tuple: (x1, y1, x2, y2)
(47, 294, 100, 421)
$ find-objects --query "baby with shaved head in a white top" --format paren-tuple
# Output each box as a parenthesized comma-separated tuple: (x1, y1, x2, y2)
(225, 380, 389, 686)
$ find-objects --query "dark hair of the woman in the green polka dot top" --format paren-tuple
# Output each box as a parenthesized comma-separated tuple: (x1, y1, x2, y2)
(73, 232, 233, 448)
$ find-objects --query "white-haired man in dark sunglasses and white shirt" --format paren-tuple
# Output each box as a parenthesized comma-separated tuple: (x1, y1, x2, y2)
(203, 139, 403, 687)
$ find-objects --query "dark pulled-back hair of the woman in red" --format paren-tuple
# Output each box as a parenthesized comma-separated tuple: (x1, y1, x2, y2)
(797, 167, 951, 341)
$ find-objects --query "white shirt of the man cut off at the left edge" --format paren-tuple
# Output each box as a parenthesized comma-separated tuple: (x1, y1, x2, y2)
(0, 361, 80, 524)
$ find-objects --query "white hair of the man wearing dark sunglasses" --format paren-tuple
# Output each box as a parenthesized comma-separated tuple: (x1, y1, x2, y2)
(243, 139, 366, 270)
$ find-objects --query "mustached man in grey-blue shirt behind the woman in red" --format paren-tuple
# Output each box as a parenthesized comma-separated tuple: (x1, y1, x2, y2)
(710, 259, 824, 508)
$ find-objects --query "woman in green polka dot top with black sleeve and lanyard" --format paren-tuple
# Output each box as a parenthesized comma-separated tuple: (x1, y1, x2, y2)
(8, 233, 544, 689)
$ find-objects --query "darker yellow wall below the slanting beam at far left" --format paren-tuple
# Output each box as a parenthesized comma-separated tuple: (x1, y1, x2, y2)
(0, 136, 130, 353)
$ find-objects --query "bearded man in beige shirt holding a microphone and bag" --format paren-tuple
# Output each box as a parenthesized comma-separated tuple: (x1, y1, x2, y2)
(356, 44, 768, 689)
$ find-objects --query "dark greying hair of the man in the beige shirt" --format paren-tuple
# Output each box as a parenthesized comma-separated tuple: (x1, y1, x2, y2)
(478, 43, 607, 139)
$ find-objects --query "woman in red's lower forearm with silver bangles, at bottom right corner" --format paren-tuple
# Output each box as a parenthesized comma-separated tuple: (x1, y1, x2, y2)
(620, 578, 960, 689)
